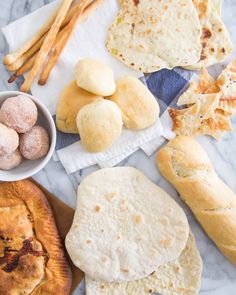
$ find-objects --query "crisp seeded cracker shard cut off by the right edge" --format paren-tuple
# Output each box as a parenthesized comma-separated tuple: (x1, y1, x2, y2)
(217, 60, 236, 115)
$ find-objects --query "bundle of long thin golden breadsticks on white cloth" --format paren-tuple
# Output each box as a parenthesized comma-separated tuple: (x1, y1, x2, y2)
(3, 0, 103, 92)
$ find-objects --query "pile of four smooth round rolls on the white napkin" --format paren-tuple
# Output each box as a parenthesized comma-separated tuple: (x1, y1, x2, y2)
(56, 58, 160, 152)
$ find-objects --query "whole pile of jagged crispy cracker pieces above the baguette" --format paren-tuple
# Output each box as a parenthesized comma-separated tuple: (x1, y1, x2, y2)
(169, 60, 236, 139)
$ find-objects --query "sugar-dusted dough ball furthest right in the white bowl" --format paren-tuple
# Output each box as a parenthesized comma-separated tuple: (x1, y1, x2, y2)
(20, 126, 49, 160)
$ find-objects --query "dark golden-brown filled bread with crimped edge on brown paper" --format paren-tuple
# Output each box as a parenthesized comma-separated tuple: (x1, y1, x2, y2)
(0, 180, 71, 295)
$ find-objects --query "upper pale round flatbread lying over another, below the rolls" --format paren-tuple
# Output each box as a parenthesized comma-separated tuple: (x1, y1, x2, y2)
(66, 167, 189, 282)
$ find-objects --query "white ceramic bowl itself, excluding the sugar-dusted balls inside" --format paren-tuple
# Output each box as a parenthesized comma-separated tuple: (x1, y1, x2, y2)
(0, 91, 56, 181)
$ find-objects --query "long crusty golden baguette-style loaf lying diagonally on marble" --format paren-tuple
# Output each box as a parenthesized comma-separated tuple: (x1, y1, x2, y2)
(157, 136, 236, 265)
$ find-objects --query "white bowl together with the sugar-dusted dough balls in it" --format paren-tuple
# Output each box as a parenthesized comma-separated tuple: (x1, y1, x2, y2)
(0, 91, 56, 181)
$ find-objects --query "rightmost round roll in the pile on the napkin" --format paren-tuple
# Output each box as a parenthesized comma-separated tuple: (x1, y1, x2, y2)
(110, 76, 160, 130)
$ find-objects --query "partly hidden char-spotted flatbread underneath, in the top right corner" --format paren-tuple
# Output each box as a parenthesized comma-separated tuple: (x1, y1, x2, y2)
(186, 0, 233, 70)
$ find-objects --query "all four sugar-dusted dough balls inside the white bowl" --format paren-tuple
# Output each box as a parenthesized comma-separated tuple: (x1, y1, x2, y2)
(0, 95, 49, 170)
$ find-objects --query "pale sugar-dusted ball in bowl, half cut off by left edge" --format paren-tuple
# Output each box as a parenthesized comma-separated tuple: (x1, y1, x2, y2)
(0, 123, 19, 156)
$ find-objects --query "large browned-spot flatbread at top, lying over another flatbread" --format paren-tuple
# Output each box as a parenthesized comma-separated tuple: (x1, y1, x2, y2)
(106, 0, 202, 73)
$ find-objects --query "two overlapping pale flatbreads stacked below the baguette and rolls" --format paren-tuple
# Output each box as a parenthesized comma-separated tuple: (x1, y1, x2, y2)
(66, 167, 202, 295)
